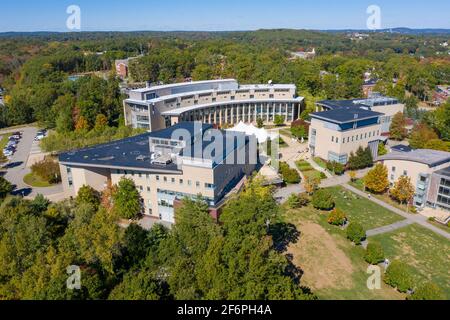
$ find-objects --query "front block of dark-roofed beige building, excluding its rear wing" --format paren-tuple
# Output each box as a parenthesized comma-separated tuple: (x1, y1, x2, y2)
(309, 109, 382, 164)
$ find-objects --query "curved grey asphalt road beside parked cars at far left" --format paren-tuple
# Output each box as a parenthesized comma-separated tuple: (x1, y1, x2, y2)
(4, 127, 63, 197)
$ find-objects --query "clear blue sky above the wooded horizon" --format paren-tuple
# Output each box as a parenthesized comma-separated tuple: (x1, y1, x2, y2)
(0, 0, 450, 32)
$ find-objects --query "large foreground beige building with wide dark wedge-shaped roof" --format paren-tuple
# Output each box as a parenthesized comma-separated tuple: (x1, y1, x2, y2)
(59, 122, 257, 223)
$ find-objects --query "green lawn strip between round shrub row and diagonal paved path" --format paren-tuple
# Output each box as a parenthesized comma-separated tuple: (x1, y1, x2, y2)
(328, 186, 404, 230)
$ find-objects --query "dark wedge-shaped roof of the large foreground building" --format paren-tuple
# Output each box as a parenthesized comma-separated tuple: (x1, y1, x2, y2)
(59, 122, 249, 172)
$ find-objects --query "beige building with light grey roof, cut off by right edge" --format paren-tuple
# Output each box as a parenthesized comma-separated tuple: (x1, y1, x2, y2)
(378, 146, 450, 211)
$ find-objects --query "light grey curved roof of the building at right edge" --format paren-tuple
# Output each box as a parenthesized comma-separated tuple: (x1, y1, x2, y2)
(378, 149, 450, 168)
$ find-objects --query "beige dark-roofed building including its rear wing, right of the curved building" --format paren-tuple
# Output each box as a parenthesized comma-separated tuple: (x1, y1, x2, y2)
(309, 96, 404, 164)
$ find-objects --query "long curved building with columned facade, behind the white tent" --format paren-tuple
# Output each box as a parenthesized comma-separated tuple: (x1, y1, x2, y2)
(124, 79, 304, 131)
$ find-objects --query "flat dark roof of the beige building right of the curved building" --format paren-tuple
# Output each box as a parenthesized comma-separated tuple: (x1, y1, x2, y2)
(311, 108, 383, 123)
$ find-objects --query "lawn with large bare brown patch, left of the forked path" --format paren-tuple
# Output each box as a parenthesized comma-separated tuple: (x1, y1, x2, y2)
(284, 187, 405, 300)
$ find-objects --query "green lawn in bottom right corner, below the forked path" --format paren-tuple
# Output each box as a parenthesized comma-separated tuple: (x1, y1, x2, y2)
(369, 224, 450, 299)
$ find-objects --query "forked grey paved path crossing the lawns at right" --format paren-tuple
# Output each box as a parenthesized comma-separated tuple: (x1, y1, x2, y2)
(342, 184, 450, 240)
